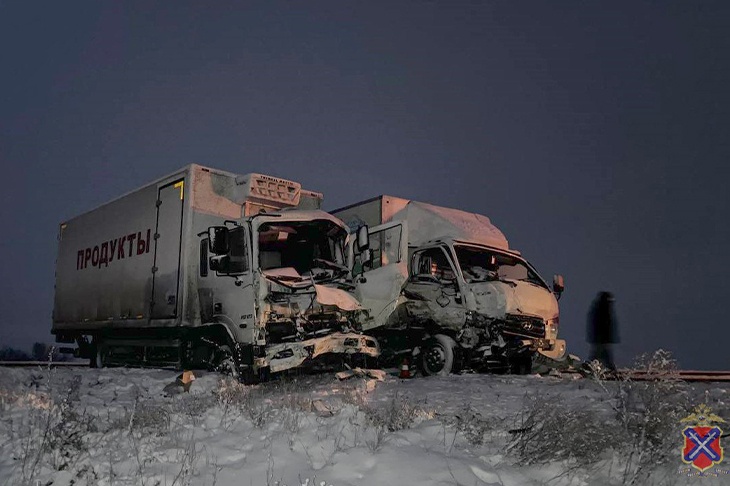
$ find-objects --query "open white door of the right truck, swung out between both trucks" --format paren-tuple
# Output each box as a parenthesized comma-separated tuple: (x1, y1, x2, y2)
(355, 221, 408, 330)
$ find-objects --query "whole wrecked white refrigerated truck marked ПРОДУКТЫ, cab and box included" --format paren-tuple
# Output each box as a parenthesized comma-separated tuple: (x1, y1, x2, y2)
(52, 165, 378, 380)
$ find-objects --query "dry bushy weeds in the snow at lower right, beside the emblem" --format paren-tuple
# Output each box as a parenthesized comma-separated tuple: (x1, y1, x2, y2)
(509, 350, 690, 484)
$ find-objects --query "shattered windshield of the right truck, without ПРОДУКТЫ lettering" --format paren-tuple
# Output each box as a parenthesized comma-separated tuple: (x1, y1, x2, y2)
(454, 245, 547, 288)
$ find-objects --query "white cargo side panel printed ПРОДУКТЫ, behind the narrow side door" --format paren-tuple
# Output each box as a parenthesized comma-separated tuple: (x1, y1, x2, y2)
(53, 178, 179, 328)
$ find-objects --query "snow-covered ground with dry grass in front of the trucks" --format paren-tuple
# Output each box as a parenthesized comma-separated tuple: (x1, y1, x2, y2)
(0, 368, 730, 486)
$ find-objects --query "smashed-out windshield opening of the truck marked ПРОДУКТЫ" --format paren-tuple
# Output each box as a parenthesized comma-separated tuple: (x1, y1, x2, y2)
(258, 220, 347, 275)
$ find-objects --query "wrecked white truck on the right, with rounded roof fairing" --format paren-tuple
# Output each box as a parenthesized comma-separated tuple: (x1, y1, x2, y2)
(332, 196, 565, 374)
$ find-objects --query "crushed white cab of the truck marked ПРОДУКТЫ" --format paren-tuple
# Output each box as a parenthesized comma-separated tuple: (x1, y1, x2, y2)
(199, 210, 378, 372)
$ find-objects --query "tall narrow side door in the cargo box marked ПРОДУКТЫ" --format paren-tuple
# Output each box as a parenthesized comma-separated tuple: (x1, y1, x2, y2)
(150, 179, 185, 319)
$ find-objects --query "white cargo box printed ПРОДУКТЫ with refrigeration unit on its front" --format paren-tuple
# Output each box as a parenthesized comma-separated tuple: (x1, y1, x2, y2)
(52, 164, 322, 333)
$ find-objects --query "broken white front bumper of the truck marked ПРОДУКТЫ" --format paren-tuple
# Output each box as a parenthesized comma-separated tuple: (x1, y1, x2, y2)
(266, 332, 380, 373)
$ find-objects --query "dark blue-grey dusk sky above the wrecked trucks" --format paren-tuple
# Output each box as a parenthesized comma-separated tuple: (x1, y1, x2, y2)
(0, 0, 730, 370)
